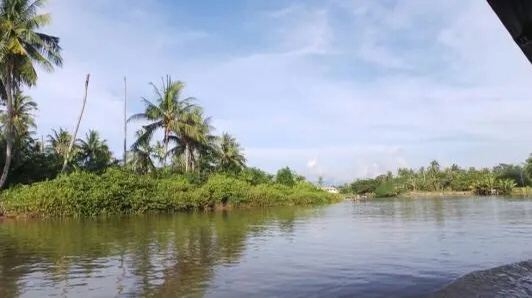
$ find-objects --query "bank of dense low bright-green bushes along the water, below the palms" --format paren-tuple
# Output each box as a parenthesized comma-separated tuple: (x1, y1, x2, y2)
(0, 169, 340, 217)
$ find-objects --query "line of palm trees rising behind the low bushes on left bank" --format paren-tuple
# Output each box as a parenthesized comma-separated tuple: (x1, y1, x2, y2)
(0, 0, 268, 187)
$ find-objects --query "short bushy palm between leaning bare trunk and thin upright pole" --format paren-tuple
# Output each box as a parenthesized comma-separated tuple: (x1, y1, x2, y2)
(78, 130, 111, 171)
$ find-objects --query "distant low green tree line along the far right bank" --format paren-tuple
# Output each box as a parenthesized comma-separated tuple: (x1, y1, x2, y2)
(340, 155, 532, 197)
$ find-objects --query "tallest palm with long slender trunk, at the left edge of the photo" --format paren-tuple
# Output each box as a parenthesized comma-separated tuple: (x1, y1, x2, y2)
(0, 0, 62, 187)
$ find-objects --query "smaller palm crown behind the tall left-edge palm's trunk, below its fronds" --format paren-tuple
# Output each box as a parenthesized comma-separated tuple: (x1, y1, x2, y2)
(0, 90, 37, 141)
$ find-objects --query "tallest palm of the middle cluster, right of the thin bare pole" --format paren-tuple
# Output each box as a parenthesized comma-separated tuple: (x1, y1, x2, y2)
(128, 76, 195, 165)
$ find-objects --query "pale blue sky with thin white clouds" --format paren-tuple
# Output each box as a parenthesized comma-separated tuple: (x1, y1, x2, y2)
(29, 0, 532, 183)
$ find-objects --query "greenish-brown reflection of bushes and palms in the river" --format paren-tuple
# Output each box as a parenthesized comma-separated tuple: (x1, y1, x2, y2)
(0, 208, 308, 297)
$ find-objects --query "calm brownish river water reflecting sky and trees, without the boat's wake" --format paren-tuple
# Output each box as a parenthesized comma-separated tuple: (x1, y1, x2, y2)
(0, 198, 532, 297)
